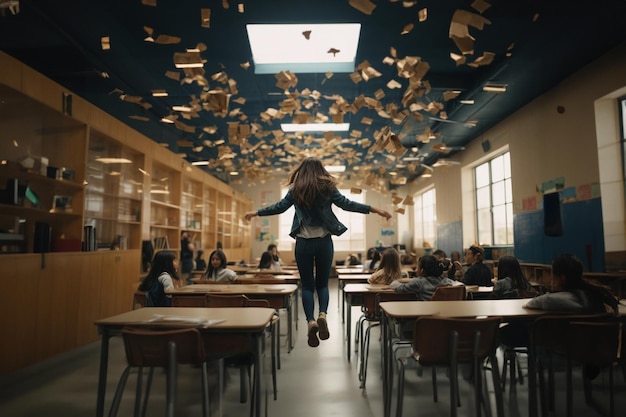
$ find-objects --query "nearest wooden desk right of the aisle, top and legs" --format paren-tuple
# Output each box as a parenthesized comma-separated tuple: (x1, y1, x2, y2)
(380, 299, 549, 417)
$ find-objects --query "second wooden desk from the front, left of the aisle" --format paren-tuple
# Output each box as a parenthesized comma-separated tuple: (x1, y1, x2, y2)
(168, 281, 298, 352)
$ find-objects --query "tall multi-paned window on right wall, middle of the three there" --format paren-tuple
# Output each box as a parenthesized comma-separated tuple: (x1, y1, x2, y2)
(474, 152, 513, 246)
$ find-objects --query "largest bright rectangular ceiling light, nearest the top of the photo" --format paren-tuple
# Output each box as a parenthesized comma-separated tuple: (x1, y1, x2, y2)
(246, 23, 361, 74)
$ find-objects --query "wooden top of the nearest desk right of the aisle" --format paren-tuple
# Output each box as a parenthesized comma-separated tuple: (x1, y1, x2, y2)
(380, 299, 550, 319)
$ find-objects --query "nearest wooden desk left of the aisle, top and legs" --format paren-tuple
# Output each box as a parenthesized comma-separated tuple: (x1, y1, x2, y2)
(95, 307, 274, 417)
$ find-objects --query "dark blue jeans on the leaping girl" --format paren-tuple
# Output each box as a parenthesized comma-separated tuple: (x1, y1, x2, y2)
(295, 235, 335, 321)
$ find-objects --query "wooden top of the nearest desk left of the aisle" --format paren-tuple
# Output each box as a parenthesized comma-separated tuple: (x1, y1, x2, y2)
(95, 307, 275, 331)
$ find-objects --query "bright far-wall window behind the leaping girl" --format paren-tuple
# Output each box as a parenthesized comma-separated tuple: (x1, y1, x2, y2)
(278, 188, 365, 252)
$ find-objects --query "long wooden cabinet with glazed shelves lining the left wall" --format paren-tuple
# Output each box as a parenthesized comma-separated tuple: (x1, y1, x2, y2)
(0, 51, 251, 374)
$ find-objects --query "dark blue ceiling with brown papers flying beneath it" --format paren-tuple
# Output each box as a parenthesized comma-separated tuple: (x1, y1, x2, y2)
(0, 0, 626, 188)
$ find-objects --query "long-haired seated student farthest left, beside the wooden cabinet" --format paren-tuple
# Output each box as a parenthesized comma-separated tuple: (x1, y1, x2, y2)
(139, 250, 182, 307)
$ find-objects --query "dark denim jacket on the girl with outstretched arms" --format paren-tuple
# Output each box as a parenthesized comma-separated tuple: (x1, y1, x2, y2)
(257, 189, 371, 239)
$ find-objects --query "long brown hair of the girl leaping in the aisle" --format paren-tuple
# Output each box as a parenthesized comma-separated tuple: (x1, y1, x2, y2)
(287, 157, 337, 207)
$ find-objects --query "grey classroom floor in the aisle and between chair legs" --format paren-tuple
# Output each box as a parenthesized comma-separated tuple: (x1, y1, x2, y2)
(0, 280, 626, 417)
